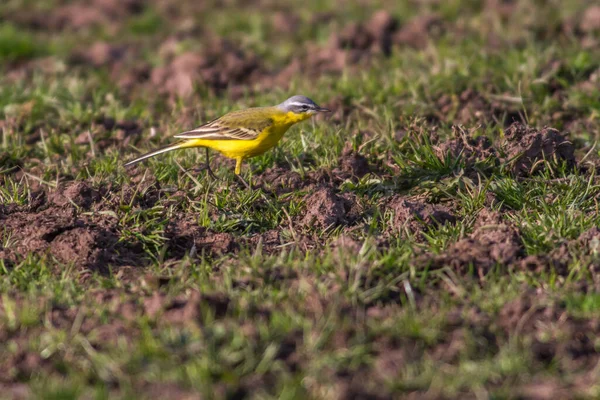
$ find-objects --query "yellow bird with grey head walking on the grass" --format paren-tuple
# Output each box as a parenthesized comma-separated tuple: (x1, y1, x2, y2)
(125, 95, 330, 185)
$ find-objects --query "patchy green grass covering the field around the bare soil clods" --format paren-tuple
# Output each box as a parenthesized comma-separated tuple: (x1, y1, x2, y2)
(0, 0, 600, 399)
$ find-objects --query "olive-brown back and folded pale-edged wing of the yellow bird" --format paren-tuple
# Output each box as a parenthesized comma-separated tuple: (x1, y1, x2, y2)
(175, 108, 273, 140)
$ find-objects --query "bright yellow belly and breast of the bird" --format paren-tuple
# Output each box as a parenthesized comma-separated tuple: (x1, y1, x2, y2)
(186, 124, 290, 158)
